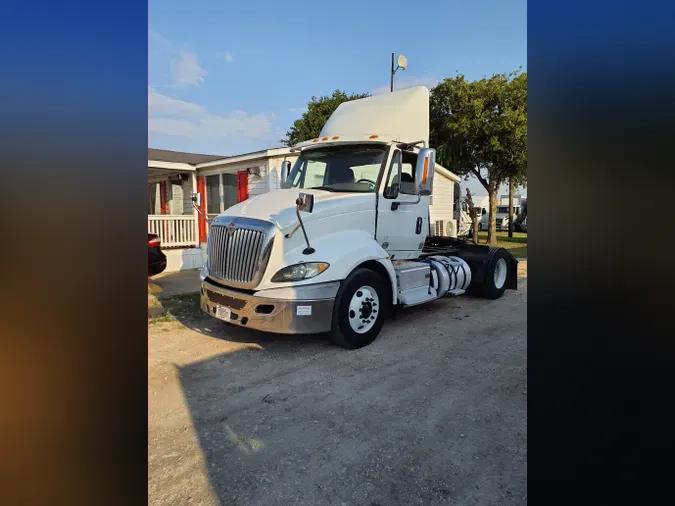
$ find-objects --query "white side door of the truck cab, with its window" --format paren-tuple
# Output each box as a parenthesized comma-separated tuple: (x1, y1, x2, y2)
(376, 149, 429, 260)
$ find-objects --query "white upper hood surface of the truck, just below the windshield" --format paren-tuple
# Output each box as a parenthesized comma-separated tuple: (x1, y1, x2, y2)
(223, 188, 375, 230)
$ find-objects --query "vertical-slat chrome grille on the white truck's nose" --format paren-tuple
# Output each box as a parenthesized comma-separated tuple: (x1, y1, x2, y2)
(208, 222, 269, 287)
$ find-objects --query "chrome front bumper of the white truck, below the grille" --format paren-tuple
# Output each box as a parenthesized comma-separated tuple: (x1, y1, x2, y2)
(201, 278, 337, 334)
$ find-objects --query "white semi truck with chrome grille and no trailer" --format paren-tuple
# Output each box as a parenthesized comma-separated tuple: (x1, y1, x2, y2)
(201, 87, 518, 349)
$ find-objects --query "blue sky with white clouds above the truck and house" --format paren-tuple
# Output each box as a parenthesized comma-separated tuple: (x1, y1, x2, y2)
(148, 0, 527, 194)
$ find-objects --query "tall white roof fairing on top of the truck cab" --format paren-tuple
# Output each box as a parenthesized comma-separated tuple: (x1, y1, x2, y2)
(320, 86, 429, 145)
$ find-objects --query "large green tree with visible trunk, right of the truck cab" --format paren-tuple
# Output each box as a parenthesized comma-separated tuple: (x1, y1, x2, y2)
(430, 71, 527, 244)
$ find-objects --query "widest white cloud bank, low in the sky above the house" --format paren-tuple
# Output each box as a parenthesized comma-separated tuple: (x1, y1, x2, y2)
(148, 87, 276, 139)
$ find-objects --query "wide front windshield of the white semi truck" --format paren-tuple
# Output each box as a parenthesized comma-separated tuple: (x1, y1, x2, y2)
(282, 144, 387, 193)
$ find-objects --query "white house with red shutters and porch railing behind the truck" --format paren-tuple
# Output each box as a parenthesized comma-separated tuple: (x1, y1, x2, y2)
(148, 148, 460, 271)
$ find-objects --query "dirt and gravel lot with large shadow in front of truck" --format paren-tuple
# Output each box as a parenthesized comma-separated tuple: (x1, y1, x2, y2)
(148, 263, 527, 506)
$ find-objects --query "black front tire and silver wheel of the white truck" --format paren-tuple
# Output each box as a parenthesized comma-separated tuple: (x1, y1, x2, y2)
(331, 269, 391, 350)
